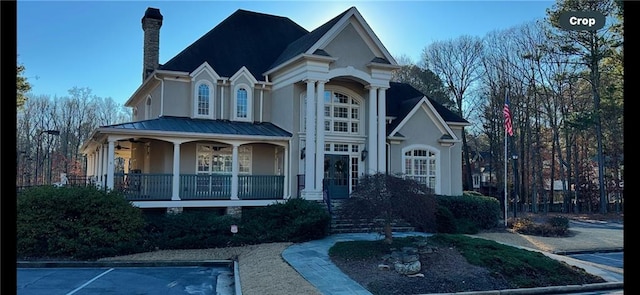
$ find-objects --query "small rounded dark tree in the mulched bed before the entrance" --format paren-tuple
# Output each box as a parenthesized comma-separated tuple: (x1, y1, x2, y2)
(341, 173, 436, 244)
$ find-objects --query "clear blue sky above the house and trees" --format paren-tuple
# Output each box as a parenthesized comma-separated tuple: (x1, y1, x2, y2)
(17, 0, 554, 104)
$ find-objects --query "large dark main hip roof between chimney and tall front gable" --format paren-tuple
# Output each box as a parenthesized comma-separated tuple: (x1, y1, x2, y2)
(160, 9, 308, 81)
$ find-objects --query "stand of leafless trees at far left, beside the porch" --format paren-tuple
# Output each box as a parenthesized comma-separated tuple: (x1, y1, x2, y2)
(16, 87, 131, 185)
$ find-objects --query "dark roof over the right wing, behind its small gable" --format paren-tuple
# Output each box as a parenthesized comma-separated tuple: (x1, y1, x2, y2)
(386, 82, 469, 132)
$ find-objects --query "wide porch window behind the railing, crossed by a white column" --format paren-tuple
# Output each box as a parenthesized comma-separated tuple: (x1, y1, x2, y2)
(196, 144, 251, 174)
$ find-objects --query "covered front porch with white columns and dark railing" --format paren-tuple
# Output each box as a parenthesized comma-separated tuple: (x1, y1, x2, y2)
(84, 118, 295, 208)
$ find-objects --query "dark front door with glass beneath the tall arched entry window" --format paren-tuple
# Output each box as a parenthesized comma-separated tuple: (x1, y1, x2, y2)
(324, 155, 349, 199)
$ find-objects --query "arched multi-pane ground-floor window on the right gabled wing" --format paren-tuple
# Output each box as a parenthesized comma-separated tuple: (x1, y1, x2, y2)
(403, 149, 437, 189)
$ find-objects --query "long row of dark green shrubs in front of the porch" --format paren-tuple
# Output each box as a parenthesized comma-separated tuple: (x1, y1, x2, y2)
(16, 186, 330, 260)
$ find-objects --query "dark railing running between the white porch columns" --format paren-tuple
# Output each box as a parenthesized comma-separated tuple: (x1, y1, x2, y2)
(109, 173, 284, 201)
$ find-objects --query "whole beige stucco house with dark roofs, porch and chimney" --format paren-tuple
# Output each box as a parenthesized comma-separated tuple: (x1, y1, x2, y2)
(83, 7, 469, 212)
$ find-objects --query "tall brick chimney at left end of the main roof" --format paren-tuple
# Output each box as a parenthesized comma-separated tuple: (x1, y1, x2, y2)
(142, 7, 162, 82)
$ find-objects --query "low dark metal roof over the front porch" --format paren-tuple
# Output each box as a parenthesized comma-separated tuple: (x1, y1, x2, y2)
(101, 116, 291, 137)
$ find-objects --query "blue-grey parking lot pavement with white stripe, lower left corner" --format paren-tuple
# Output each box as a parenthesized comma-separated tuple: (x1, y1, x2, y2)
(17, 266, 234, 295)
